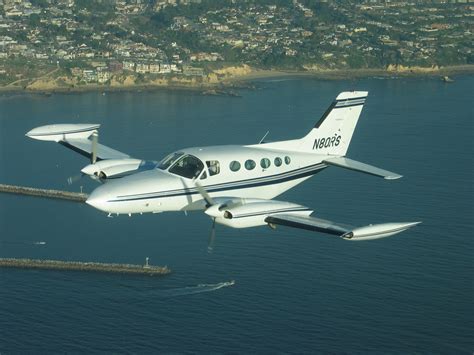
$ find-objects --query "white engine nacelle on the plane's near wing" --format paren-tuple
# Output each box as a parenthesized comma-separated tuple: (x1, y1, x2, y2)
(211, 200, 313, 228)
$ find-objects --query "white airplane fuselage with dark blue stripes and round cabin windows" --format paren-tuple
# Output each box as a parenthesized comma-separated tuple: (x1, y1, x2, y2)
(87, 143, 327, 214)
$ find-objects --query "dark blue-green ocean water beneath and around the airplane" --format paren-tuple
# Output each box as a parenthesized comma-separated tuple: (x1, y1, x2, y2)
(0, 76, 474, 354)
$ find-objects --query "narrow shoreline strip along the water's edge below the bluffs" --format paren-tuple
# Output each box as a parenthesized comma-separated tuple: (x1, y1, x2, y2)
(0, 65, 474, 96)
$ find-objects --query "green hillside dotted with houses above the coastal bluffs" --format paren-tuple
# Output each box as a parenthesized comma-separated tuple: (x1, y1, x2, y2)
(0, 0, 474, 84)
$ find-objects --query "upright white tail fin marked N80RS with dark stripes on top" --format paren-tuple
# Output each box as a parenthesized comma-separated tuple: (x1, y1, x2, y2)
(300, 91, 368, 156)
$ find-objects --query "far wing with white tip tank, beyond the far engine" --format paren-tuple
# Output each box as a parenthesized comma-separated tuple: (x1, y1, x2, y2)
(26, 123, 130, 161)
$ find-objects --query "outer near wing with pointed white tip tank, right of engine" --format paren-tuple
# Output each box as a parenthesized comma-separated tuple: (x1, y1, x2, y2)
(265, 214, 421, 240)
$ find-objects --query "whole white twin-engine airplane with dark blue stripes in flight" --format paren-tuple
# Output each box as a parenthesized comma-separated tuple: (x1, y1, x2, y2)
(26, 91, 421, 250)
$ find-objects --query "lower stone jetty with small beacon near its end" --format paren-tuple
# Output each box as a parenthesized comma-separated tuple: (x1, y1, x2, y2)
(0, 258, 171, 276)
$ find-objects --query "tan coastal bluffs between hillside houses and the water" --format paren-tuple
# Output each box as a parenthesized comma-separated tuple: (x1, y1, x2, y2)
(0, 64, 474, 92)
